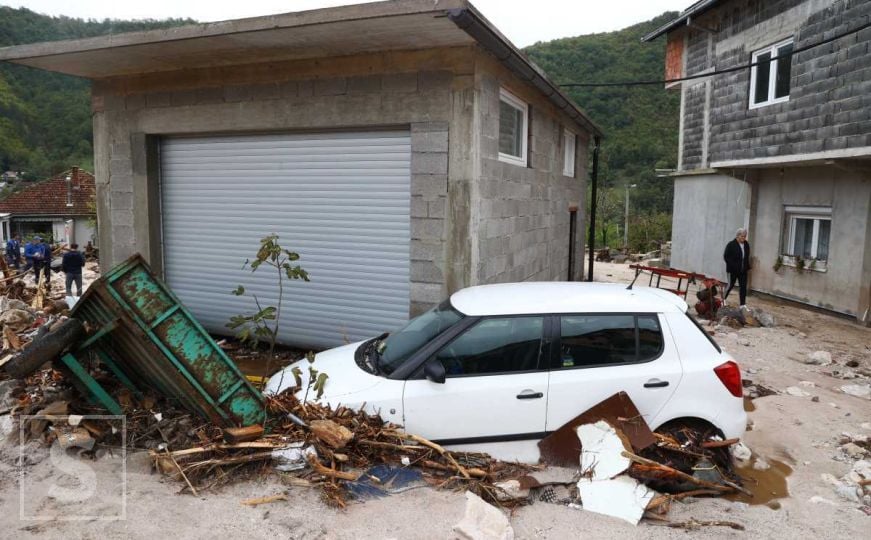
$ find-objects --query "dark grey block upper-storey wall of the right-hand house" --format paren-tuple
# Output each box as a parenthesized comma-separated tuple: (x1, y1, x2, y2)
(682, 0, 871, 170)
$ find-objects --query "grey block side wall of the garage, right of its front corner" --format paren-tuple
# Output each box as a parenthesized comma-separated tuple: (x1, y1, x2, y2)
(471, 53, 590, 283)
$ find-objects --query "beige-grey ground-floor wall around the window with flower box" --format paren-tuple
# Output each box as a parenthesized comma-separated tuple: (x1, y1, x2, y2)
(750, 167, 871, 319)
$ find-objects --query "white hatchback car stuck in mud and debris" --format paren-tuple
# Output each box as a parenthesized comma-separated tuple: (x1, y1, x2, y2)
(267, 282, 747, 462)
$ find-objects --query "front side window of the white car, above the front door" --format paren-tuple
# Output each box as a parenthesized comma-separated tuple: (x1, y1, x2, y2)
(435, 317, 544, 377)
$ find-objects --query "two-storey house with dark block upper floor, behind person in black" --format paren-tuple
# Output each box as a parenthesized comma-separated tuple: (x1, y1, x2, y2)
(644, 0, 871, 323)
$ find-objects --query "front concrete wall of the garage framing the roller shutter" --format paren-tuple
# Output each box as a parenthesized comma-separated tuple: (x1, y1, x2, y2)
(92, 47, 475, 314)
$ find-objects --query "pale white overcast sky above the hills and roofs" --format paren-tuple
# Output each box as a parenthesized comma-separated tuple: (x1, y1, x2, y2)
(0, 0, 694, 47)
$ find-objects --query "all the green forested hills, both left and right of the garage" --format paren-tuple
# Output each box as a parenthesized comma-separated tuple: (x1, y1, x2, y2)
(0, 6, 680, 250)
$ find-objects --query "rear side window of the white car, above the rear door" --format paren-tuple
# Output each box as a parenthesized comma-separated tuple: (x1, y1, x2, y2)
(557, 314, 663, 368)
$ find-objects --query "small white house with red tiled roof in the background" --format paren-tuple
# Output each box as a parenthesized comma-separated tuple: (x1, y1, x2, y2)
(0, 167, 97, 246)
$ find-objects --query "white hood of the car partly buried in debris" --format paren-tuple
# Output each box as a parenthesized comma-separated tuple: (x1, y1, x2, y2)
(264, 341, 382, 402)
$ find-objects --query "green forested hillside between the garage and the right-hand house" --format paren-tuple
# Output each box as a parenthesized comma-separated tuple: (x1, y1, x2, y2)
(525, 13, 680, 251)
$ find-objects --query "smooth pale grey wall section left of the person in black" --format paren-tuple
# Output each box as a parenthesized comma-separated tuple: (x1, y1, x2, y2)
(671, 173, 756, 281)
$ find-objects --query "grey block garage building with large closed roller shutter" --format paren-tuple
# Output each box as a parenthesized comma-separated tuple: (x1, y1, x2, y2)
(0, 0, 600, 347)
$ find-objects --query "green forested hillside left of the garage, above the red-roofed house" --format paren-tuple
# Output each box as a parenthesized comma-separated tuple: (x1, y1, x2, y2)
(0, 6, 194, 178)
